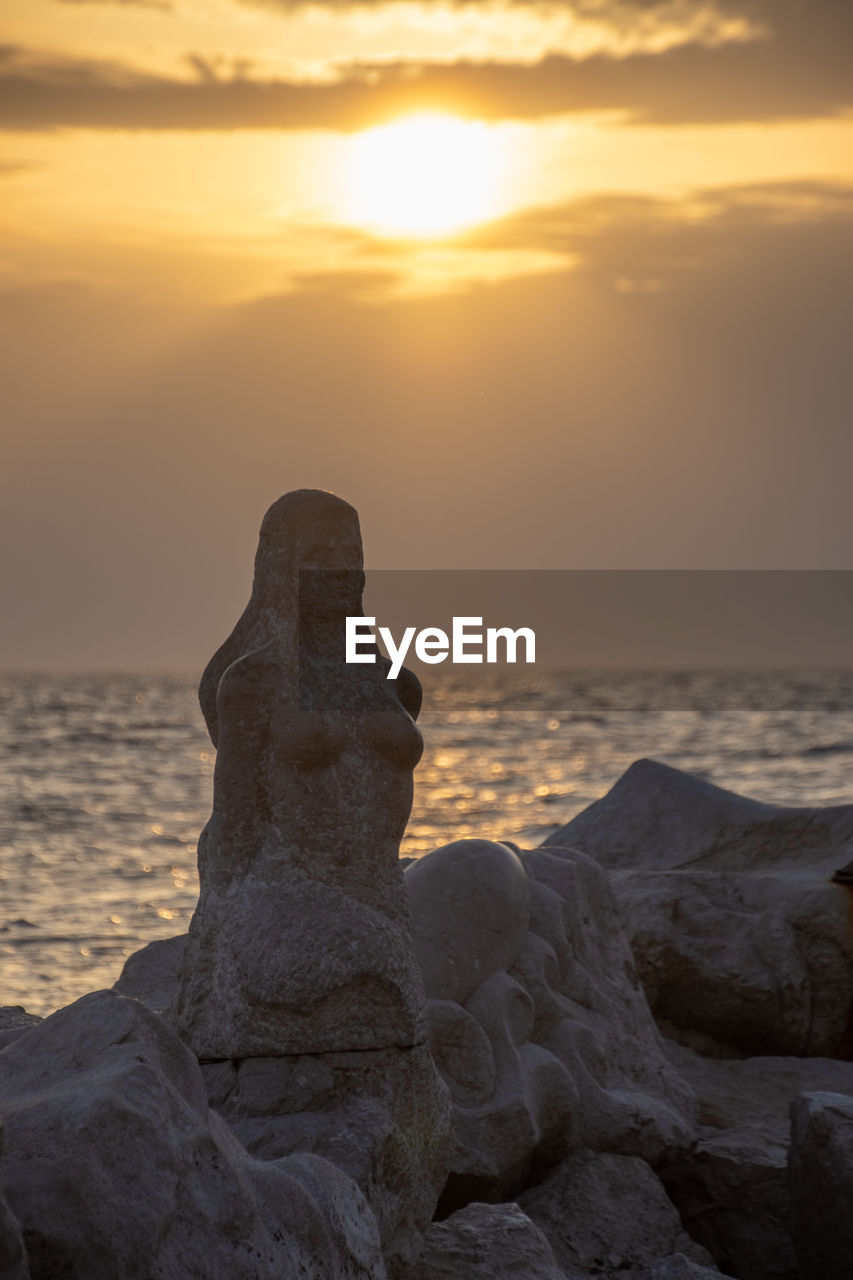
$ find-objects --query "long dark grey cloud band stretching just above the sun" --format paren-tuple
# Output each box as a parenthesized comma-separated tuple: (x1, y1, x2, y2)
(0, 0, 853, 131)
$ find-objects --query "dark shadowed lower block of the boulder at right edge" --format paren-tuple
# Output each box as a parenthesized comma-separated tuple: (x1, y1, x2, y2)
(612, 870, 853, 1057)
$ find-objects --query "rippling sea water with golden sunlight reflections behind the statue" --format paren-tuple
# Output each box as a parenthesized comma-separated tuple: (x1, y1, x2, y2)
(0, 668, 853, 1014)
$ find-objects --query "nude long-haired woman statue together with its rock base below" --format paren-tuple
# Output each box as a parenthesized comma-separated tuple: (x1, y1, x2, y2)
(162, 490, 450, 1271)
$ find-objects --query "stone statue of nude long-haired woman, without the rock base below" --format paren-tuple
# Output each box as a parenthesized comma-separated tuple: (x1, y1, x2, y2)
(174, 489, 425, 1060)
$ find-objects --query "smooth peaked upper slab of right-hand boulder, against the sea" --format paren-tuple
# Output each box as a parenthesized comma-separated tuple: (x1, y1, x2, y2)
(543, 760, 853, 877)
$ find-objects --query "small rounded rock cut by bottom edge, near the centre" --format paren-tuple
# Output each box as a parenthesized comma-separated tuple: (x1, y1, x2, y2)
(409, 1203, 565, 1280)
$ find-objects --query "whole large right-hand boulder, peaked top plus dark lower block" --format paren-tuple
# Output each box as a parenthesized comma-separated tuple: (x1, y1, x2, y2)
(543, 760, 853, 1057)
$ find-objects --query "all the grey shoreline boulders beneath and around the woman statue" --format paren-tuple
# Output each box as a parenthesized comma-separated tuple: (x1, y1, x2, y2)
(0, 762, 853, 1280)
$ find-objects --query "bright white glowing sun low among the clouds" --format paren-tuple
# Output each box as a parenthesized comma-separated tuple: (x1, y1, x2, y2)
(343, 114, 502, 238)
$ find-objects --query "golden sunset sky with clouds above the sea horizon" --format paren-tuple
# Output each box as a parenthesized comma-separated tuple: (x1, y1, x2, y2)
(0, 0, 853, 669)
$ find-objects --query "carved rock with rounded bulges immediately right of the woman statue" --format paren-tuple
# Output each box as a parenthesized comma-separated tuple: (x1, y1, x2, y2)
(417, 841, 690, 1211)
